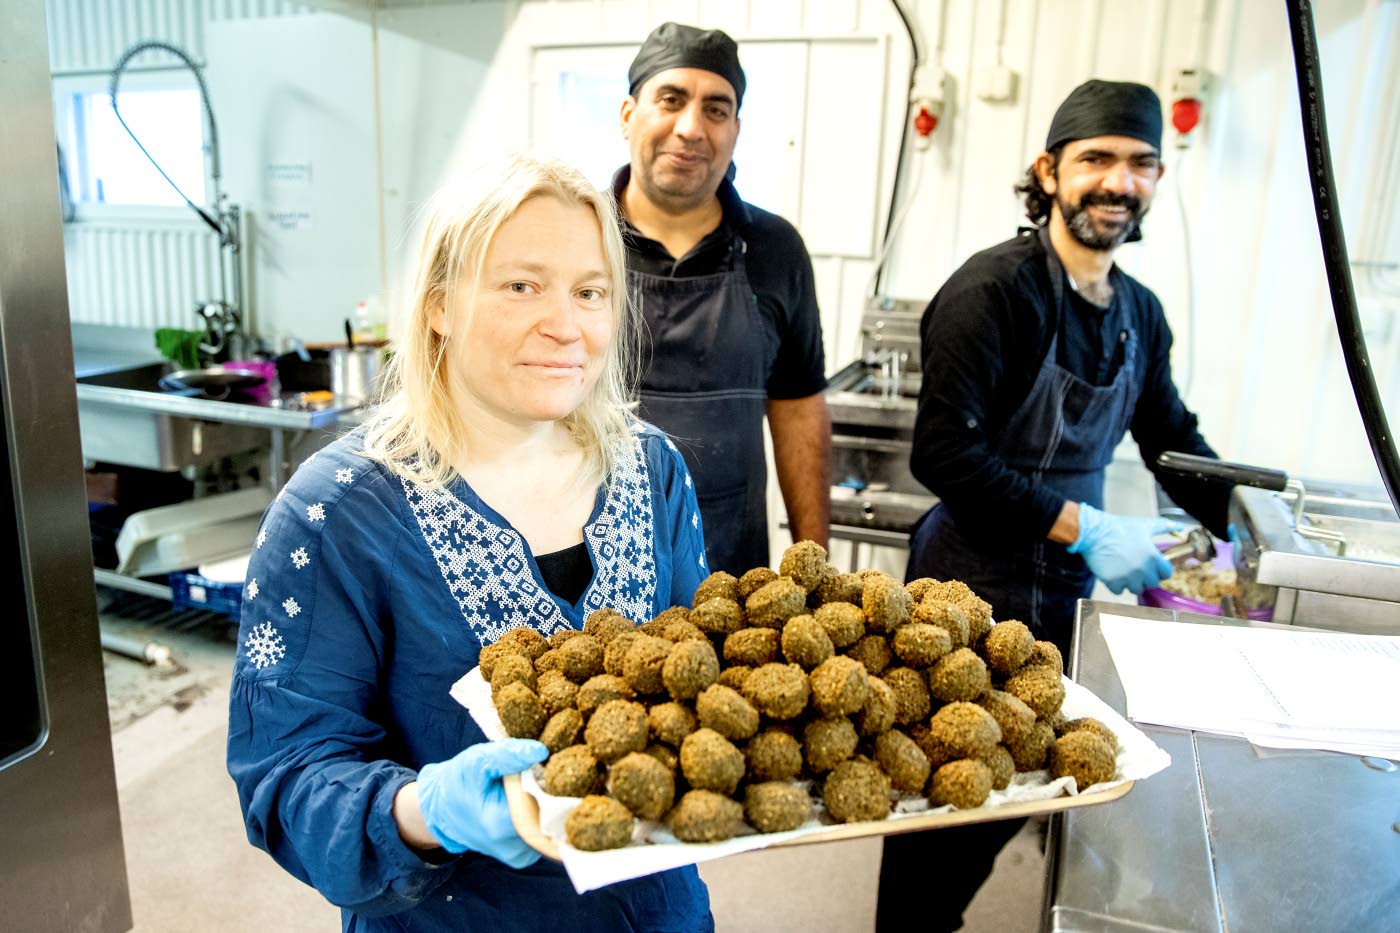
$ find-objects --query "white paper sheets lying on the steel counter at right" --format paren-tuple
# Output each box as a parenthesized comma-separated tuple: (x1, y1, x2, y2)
(1099, 615, 1400, 758)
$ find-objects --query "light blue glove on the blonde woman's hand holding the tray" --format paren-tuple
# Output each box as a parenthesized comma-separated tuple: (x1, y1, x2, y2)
(419, 738, 549, 869)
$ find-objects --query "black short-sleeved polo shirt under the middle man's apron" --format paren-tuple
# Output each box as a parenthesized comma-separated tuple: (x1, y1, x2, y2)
(613, 165, 826, 399)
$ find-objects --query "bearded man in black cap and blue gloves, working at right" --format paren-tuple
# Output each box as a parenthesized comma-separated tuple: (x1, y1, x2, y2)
(876, 80, 1228, 930)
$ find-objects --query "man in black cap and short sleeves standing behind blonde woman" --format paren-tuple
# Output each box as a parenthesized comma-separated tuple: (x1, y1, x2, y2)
(613, 22, 832, 576)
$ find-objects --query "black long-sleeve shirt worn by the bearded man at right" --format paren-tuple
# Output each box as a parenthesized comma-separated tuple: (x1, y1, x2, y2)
(911, 233, 1229, 542)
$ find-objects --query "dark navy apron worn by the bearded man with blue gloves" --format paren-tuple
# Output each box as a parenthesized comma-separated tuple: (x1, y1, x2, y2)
(906, 227, 1144, 653)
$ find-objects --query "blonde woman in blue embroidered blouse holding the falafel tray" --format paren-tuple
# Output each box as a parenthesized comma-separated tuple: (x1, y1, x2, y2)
(228, 157, 713, 933)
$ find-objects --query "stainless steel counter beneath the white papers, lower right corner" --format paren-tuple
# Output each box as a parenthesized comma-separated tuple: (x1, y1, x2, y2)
(1043, 602, 1400, 933)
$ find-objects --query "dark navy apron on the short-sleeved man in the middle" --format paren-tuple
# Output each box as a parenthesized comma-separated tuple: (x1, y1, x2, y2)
(627, 237, 778, 576)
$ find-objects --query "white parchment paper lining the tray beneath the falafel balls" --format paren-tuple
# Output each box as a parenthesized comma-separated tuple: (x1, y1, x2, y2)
(452, 668, 1172, 894)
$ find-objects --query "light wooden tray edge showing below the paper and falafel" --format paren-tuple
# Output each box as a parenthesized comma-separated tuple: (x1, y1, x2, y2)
(503, 775, 1134, 862)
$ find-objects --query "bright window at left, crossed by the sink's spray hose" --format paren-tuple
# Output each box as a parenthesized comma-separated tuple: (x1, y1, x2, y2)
(55, 76, 206, 216)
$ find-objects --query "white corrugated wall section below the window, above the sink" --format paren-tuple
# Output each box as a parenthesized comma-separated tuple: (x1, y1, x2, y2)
(64, 223, 220, 331)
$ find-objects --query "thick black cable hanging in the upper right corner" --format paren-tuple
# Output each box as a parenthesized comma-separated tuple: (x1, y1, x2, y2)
(1288, 0, 1400, 511)
